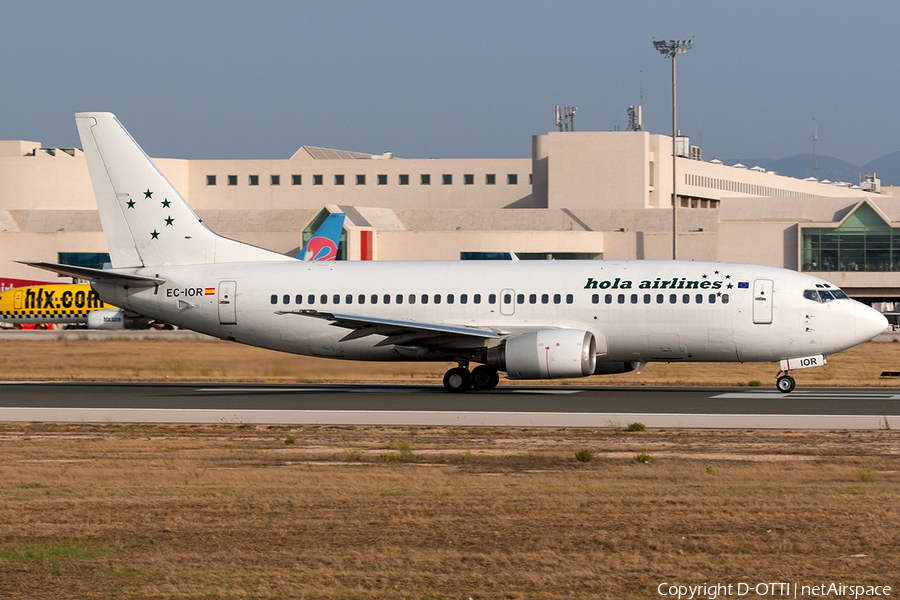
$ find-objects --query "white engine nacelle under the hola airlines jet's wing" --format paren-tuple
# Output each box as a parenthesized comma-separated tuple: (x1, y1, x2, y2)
(487, 329, 597, 379)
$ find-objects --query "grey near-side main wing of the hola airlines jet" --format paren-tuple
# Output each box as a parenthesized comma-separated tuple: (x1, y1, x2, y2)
(275, 310, 500, 348)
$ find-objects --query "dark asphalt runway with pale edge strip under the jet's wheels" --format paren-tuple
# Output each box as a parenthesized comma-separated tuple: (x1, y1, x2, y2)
(0, 382, 900, 429)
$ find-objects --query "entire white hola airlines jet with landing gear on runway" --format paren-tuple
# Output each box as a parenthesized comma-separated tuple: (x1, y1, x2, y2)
(21, 113, 888, 393)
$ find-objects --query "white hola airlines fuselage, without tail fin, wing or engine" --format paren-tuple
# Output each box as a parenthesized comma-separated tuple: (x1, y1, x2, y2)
(94, 261, 885, 362)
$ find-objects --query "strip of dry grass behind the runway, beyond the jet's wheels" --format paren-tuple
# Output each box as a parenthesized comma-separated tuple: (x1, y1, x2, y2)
(0, 339, 900, 387)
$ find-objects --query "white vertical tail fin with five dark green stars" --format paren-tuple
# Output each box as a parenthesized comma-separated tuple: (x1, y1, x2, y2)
(75, 113, 293, 268)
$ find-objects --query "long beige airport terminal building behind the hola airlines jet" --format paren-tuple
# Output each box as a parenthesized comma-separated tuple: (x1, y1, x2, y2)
(0, 131, 900, 302)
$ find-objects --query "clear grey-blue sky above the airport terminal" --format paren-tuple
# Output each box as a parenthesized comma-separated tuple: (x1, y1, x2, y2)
(0, 0, 900, 164)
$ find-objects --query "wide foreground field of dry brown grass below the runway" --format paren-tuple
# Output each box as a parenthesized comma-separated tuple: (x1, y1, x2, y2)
(0, 424, 900, 599)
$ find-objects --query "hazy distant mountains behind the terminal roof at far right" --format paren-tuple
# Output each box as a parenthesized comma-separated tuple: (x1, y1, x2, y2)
(720, 151, 900, 185)
